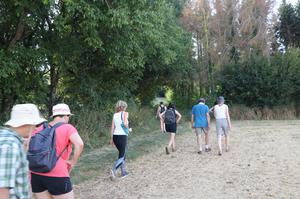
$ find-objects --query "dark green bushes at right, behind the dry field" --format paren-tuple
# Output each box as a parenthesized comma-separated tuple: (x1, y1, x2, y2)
(220, 49, 300, 108)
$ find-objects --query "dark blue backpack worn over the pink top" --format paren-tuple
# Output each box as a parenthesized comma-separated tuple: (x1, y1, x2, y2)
(27, 122, 68, 173)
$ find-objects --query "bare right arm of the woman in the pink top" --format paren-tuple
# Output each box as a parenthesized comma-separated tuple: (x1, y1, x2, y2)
(68, 133, 83, 172)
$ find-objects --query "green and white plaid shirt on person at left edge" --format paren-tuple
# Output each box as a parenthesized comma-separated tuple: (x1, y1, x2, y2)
(0, 128, 29, 199)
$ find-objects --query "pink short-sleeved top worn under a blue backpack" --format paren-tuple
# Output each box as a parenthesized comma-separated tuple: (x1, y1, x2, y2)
(31, 124, 78, 177)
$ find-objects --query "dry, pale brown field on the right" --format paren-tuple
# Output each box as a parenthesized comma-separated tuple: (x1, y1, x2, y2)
(74, 120, 300, 199)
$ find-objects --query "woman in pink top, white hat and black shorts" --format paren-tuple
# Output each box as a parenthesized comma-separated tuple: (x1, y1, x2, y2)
(31, 104, 83, 199)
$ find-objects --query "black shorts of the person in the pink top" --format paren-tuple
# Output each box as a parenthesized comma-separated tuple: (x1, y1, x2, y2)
(31, 173, 72, 195)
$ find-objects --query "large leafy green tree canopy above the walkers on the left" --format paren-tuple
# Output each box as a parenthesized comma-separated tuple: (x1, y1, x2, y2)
(0, 0, 191, 119)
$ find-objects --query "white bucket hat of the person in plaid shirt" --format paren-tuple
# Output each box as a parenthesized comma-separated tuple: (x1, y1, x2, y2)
(5, 104, 46, 127)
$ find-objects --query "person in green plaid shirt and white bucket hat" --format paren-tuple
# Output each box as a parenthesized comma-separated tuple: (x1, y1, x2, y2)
(0, 104, 46, 199)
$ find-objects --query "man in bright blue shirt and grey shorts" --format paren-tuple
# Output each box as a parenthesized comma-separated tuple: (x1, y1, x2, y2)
(191, 98, 211, 154)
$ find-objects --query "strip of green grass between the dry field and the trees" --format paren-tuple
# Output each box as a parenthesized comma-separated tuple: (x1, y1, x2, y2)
(72, 118, 186, 184)
